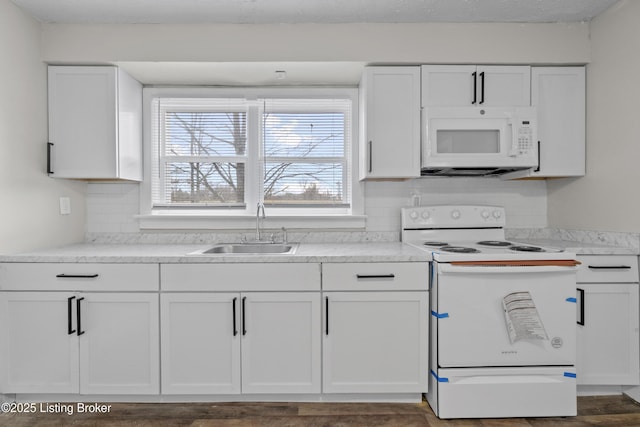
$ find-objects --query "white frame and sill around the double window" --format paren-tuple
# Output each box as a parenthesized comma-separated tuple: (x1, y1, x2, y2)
(138, 87, 365, 230)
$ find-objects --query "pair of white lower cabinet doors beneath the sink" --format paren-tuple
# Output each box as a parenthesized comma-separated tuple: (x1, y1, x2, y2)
(161, 292, 321, 394)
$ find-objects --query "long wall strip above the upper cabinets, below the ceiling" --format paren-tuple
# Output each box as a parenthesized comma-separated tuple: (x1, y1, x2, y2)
(43, 23, 589, 64)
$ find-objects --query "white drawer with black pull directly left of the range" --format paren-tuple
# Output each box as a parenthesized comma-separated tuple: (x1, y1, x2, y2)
(322, 262, 429, 291)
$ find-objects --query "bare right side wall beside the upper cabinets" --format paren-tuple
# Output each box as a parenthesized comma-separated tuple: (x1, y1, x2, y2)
(548, 0, 640, 232)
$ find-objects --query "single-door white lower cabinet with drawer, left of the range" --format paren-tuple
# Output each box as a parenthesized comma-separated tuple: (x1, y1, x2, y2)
(322, 263, 429, 393)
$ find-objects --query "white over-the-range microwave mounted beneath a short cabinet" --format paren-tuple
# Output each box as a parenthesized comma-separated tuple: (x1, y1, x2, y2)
(422, 107, 538, 176)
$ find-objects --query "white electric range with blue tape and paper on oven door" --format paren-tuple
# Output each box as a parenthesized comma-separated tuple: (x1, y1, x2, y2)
(402, 206, 578, 418)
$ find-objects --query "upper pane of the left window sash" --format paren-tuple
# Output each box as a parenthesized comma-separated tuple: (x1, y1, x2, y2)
(164, 111, 247, 156)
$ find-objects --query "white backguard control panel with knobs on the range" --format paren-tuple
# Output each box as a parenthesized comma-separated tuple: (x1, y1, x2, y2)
(401, 205, 505, 229)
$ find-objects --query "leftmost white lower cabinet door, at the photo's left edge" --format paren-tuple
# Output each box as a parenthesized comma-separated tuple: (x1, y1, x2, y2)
(0, 292, 79, 393)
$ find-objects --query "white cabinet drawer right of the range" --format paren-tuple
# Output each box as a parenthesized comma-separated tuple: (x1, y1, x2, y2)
(578, 255, 638, 283)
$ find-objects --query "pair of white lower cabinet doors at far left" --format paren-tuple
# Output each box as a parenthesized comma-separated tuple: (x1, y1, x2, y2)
(0, 291, 159, 394)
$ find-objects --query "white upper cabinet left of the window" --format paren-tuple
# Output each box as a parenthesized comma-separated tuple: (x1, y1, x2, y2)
(47, 66, 142, 181)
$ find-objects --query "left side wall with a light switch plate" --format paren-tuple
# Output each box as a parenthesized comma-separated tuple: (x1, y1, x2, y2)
(0, 0, 85, 253)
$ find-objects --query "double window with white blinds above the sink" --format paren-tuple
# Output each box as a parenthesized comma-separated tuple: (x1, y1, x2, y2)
(141, 89, 360, 227)
